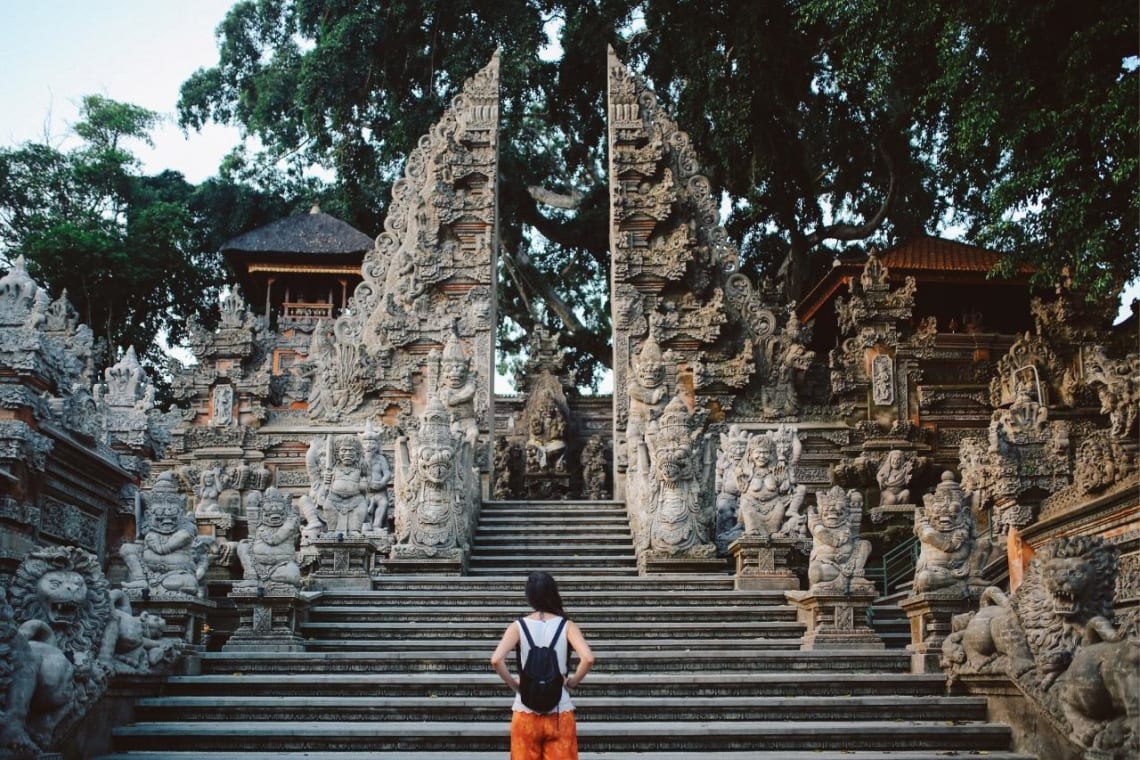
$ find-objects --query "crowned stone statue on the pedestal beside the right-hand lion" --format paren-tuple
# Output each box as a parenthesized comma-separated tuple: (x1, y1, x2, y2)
(913, 472, 991, 597)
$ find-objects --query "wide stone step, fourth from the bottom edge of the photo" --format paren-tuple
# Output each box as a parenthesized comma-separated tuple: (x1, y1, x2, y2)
(164, 669, 946, 698)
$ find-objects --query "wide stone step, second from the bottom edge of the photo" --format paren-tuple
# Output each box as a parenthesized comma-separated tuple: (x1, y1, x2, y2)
(114, 720, 1010, 753)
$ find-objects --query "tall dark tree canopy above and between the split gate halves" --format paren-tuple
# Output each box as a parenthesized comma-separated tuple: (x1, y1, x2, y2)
(166, 0, 1140, 384)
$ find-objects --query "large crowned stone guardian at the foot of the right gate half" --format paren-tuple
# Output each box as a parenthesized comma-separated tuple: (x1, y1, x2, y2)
(629, 397, 716, 564)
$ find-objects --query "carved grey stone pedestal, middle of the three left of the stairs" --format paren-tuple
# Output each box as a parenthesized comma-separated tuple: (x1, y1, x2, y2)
(221, 581, 310, 652)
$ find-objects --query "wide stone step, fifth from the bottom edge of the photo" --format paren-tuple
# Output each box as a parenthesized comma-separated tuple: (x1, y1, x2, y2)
(201, 646, 910, 677)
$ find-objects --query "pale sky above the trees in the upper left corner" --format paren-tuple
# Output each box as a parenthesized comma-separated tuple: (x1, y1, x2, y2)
(0, 0, 239, 182)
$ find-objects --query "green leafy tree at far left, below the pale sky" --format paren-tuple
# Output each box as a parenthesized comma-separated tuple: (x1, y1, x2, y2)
(0, 96, 284, 380)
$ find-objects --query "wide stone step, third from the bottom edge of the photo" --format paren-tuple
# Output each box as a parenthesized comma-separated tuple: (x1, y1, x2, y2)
(136, 688, 986, 722)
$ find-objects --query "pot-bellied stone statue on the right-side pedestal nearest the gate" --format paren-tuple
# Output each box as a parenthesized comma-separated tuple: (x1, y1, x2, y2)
(739, 425, 807, 538)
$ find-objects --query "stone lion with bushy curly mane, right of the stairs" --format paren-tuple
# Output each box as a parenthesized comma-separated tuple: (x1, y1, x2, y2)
(943, 536, 1119, 692)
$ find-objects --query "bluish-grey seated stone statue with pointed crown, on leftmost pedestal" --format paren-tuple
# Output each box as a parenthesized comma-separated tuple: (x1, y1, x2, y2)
(120, 471, 210, 598)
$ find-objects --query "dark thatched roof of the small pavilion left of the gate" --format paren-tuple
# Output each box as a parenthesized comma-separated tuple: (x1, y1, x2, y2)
(221, 206, 373, 255)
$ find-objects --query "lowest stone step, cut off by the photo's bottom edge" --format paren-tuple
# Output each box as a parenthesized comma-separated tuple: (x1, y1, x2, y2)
(98, 750, 1036, 760)
